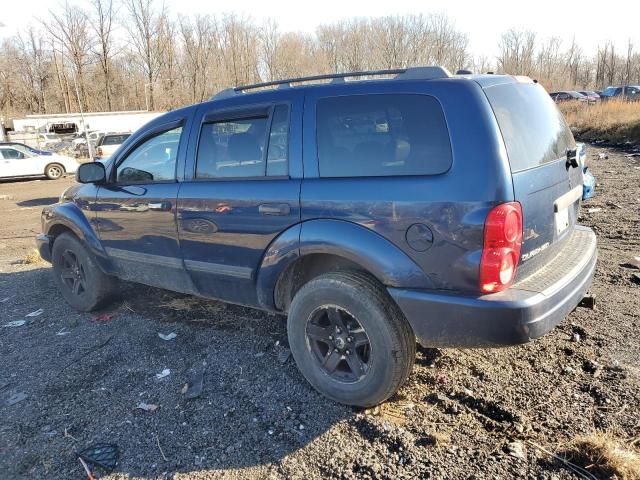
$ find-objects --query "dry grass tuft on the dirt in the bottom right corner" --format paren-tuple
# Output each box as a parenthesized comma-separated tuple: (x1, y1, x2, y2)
(566, 432, 640, 480)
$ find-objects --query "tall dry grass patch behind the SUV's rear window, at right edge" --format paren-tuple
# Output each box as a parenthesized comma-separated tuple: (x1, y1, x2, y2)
(560, 100, 640, 143)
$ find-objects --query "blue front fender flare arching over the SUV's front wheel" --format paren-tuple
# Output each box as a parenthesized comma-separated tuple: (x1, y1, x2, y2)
(42, 201, 115, 274)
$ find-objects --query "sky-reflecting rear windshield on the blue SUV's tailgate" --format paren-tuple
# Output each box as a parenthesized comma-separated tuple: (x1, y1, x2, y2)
(485, 83, 575, 172)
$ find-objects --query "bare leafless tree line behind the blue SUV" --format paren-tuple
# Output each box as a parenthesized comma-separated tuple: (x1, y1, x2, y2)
(0, 0, 640, 117)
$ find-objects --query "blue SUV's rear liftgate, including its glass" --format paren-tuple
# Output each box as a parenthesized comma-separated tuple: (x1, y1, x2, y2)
(485, 82, 583, 270)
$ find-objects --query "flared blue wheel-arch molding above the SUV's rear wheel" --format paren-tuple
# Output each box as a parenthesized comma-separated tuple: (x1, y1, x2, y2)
(257, 219, 433, 310)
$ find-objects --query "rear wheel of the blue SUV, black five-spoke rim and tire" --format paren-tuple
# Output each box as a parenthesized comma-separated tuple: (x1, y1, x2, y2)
(287, 272, 416, 407)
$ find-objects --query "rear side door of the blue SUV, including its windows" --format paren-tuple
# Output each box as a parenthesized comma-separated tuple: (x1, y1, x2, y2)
(178, 92, 302, 305)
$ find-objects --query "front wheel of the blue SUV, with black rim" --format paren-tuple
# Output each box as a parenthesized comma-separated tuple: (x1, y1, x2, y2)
(51, 233, 118, 312)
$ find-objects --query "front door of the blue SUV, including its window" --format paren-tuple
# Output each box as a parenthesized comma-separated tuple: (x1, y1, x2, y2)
(95, 122, 193, 292)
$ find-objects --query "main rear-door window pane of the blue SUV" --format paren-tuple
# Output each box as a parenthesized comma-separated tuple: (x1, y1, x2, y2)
(196, 117, 268, 178)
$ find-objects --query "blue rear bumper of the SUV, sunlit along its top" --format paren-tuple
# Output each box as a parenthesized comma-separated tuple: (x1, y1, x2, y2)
(389, 226, 597, 347)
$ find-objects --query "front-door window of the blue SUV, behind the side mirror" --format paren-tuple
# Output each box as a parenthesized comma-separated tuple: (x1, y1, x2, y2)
(118, 127, 182, 183)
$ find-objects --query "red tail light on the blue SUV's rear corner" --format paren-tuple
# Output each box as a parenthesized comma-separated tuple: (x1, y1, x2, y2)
(480, 202, 522, 293)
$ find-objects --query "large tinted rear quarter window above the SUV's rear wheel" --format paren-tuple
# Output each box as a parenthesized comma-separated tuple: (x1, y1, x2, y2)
(317, 95, 451, 177)
